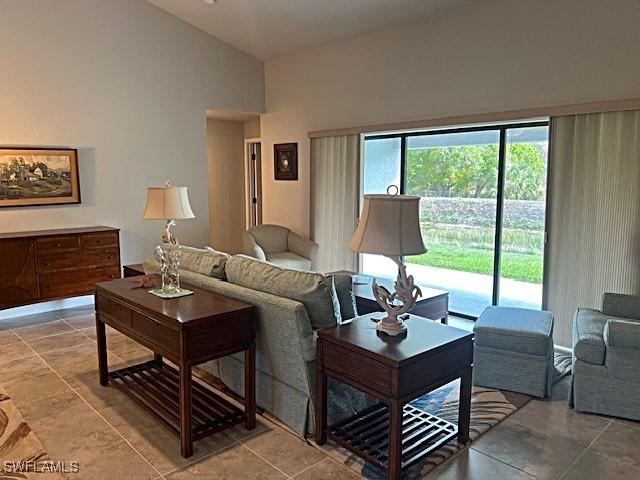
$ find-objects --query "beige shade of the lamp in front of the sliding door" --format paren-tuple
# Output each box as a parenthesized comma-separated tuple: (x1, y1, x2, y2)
(349, 195, 427, 257)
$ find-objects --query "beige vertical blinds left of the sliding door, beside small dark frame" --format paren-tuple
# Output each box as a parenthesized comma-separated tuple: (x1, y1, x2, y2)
(311, 135, 360, 272)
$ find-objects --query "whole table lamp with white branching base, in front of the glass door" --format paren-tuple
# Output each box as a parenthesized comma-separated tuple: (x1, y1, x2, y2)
(349, 186, 427, 335)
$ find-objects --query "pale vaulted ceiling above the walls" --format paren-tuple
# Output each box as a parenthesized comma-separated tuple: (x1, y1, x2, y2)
(148, 0, 469, 60)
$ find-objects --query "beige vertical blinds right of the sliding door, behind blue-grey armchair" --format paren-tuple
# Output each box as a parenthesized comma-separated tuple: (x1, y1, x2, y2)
(545, 111, 640, 347)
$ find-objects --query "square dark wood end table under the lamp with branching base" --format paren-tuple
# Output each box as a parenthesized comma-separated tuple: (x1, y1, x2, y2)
(316, 314, 473, 480)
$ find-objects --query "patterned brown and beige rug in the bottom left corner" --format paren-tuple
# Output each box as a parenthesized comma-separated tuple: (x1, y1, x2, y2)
(0, 387, 63, 480)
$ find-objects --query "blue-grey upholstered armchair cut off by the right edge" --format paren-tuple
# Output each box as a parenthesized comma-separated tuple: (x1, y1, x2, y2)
(569, 293, 640, 420)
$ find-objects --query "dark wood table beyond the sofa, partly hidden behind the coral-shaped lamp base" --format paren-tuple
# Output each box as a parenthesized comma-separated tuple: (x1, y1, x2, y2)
(332, 270, 449, 324)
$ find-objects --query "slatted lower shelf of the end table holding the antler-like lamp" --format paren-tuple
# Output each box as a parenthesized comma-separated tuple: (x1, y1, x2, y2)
(327, 403, 458, 470)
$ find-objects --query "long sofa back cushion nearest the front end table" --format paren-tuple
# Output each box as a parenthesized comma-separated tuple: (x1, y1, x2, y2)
(226, 255, 342, 329)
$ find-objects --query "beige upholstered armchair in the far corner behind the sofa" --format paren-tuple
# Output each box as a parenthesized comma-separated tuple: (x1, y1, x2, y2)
(244, 225, 318, 270)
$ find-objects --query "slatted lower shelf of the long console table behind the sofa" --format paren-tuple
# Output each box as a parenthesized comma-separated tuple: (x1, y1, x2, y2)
(109, 360, 246, 441)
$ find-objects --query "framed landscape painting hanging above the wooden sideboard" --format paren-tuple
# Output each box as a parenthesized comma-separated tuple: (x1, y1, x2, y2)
(0, 148, 80, 207)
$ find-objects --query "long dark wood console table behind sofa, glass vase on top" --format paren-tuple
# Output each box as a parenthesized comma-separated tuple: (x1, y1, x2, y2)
(95, 276, 256, 457)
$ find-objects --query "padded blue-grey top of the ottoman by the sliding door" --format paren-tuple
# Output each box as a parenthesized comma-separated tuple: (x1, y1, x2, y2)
(473, 307, 553, 356)
